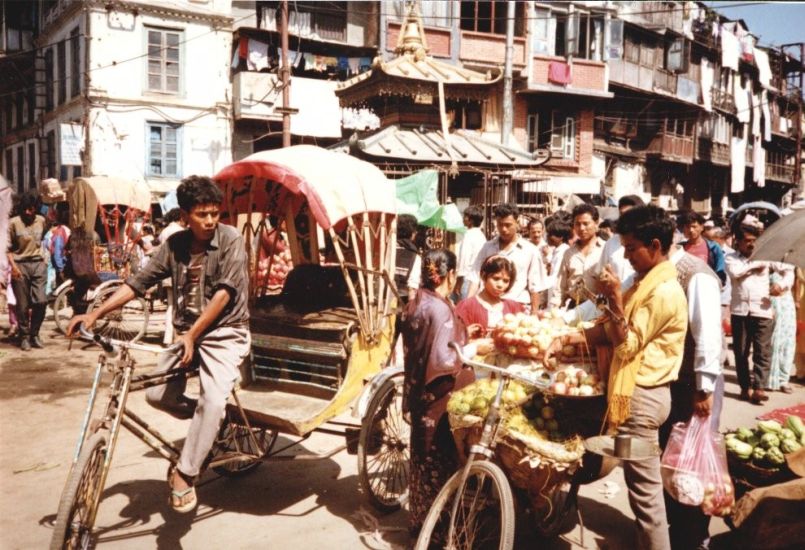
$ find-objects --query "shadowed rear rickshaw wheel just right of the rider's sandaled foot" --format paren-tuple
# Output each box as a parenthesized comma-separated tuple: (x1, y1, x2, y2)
(209, 412, 277, 477)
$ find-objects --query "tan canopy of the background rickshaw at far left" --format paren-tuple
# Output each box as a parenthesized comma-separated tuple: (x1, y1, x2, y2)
(67, 176, 151, 231)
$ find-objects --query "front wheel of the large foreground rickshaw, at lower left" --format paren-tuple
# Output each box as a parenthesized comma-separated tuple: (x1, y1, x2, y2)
(50, 432, 108, 550)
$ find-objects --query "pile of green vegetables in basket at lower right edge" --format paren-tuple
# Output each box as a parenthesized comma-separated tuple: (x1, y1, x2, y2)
(724, 416, 805, 469)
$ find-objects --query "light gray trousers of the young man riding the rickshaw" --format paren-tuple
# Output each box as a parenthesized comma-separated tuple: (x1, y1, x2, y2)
(145, 327, 251, 477)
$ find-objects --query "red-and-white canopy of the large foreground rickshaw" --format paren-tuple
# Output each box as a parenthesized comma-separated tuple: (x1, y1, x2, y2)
(214, 145, 396, 230)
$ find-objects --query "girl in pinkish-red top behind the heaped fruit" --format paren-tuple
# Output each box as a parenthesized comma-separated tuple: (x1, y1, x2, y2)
(456, 256, 525, 339)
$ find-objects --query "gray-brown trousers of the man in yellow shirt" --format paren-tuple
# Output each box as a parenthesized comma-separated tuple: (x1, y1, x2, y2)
(618, 385, 671, 550)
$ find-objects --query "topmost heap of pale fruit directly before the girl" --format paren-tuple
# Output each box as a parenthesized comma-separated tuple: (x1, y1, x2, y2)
(492, 309, 586, 360)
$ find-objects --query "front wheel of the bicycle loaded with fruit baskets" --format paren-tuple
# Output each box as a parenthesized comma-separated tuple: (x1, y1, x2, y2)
(414, 460, 514, 550)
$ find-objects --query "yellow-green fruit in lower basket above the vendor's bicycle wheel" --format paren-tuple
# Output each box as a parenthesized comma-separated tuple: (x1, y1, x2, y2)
(447, 384, 584, 464)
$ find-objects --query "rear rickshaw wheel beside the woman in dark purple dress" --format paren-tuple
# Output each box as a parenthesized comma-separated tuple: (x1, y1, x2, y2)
(358, 376, 411, 513)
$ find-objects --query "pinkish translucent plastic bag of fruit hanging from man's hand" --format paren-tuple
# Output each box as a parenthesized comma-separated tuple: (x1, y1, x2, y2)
(662, 415, 735, 516)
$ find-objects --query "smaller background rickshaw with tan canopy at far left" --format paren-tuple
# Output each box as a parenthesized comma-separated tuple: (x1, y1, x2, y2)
(52, 176, 151, 341)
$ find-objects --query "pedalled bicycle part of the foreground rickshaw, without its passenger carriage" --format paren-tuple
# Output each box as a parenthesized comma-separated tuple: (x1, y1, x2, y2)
(50, 327, 270, 550)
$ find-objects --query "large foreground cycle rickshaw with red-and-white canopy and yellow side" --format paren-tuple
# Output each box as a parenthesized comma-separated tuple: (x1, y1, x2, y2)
(51, 145, 409, 549)
